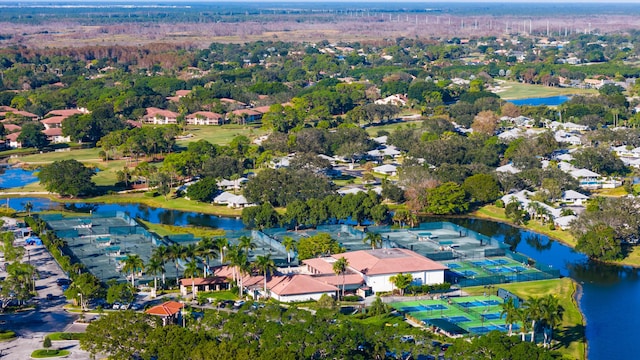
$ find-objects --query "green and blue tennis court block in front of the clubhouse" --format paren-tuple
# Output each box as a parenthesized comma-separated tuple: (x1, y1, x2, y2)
(390, 295, 519, 335)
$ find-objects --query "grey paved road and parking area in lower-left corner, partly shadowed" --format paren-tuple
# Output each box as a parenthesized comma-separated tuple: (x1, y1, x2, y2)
(0, 243, 95, 360)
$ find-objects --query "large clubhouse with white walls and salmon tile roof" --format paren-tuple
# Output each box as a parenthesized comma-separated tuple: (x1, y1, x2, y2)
(303, 248, 447, 293)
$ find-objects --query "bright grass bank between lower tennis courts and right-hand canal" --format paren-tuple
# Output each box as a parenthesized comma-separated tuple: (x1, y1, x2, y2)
(464, 278, 587, 359)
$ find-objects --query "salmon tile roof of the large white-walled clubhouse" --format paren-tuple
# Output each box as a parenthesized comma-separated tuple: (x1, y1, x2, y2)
(331, 248, 447, 275)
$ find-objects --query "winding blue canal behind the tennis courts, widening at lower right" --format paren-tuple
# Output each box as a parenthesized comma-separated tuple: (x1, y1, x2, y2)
(5, 198, 640, 359)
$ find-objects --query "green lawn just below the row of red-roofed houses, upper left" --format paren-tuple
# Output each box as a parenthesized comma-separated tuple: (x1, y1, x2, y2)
(177, 124, 267, 146)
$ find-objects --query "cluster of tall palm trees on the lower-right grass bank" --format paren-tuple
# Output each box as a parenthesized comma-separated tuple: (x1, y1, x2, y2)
(500, 294, 564, 347)
